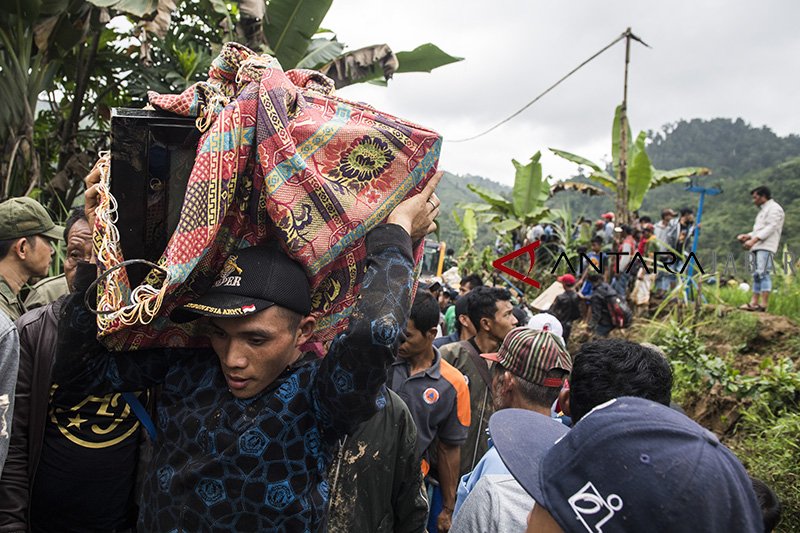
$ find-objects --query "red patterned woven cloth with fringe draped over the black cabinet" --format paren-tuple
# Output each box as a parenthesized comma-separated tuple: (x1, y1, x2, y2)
(95, 43, 441, 350)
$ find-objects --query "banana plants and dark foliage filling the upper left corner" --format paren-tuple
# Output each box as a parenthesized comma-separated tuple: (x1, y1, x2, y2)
(0, 0, 461, 206)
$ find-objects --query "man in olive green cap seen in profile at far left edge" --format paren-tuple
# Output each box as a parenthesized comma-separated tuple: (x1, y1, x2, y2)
(0, 197, 64, 320)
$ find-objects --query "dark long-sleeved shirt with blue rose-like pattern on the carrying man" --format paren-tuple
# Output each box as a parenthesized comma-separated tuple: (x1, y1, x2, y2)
(54, 225, 414, 532)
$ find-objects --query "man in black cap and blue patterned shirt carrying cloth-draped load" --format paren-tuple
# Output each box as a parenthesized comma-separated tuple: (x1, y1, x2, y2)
(54, 169, 441, 532)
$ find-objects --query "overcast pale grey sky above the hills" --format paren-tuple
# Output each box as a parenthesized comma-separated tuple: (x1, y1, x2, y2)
(323, 0, 800, 184)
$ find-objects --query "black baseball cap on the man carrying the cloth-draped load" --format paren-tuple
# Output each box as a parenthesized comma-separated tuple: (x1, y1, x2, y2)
(170, 242, 311, 323)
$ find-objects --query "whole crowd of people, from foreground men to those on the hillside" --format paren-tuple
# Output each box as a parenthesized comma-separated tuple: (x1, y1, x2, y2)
(0, 169, 783, 533)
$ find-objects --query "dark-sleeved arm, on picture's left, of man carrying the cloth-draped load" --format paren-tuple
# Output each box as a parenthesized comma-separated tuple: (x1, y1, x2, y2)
(53, 263, 184, 394)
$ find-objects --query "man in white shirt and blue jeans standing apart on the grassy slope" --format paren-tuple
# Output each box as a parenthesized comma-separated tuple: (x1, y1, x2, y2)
(736, 185, 784, 311)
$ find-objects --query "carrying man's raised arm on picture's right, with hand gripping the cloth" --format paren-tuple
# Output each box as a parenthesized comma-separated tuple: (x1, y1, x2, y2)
(313, 172, 442, 436)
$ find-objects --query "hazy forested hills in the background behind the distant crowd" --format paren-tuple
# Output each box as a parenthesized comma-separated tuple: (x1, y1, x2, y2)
(440, 118, 800, 264)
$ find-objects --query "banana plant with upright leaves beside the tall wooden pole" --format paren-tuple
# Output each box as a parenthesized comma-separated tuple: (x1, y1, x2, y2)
(550, 106, 711, 222)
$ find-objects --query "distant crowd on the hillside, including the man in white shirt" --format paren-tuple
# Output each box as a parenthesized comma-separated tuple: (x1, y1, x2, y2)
(517, 186, 785, 339)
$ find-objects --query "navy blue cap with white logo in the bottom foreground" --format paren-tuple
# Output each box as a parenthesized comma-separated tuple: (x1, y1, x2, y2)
(492, 397, 764, 533)
